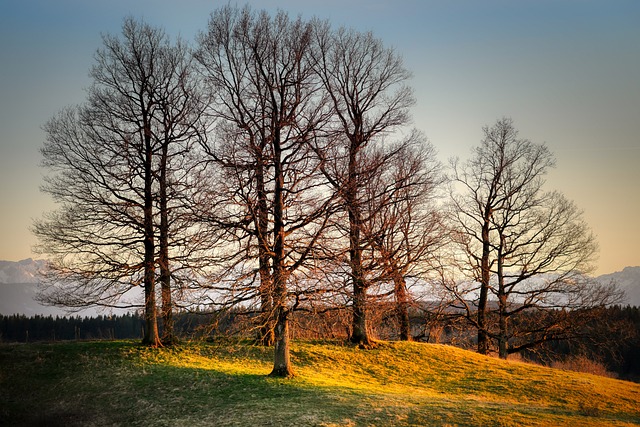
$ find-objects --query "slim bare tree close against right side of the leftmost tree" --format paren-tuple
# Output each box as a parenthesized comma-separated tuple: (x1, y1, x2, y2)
(153, 36, 210, 344)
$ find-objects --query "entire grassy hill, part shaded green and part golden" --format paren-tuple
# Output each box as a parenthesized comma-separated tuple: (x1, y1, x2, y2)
(0, 341, 640, 427)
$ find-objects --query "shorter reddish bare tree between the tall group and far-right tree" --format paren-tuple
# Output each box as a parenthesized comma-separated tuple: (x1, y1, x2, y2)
(364, 139, 446, 340)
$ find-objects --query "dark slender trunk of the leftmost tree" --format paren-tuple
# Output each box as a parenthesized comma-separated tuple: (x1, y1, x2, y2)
(142, 120, 160, 347)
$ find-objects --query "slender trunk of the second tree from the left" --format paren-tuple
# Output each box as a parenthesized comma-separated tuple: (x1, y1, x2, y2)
(158, 141, 175, 345)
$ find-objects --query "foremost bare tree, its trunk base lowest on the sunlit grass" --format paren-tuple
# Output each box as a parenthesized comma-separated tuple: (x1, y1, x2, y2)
(197, 6, 332, 377)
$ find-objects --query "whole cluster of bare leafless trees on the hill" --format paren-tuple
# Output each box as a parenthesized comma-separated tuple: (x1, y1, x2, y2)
(33, 6, 615, 376)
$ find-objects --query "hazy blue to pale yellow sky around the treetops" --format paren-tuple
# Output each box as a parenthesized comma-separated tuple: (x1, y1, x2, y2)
(0, 0, 640, 274)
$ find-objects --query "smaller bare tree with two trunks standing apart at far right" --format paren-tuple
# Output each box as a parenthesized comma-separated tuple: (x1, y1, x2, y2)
(449, 119, 613, 358)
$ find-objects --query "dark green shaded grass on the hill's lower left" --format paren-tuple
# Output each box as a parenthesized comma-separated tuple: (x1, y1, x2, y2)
(0, 343, 360, 426)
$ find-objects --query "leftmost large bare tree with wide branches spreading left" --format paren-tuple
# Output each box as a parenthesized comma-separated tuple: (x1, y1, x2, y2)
(33, 18, 206, 346)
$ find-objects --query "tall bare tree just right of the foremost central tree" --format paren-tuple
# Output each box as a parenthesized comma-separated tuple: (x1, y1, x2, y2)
(314, 22, 414, 347)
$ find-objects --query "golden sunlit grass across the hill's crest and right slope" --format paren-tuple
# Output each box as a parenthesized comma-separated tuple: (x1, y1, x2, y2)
(115, 342, 640, 426)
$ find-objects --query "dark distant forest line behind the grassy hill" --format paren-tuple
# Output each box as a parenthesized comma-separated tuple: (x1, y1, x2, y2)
(0, 304, 640, 381)
